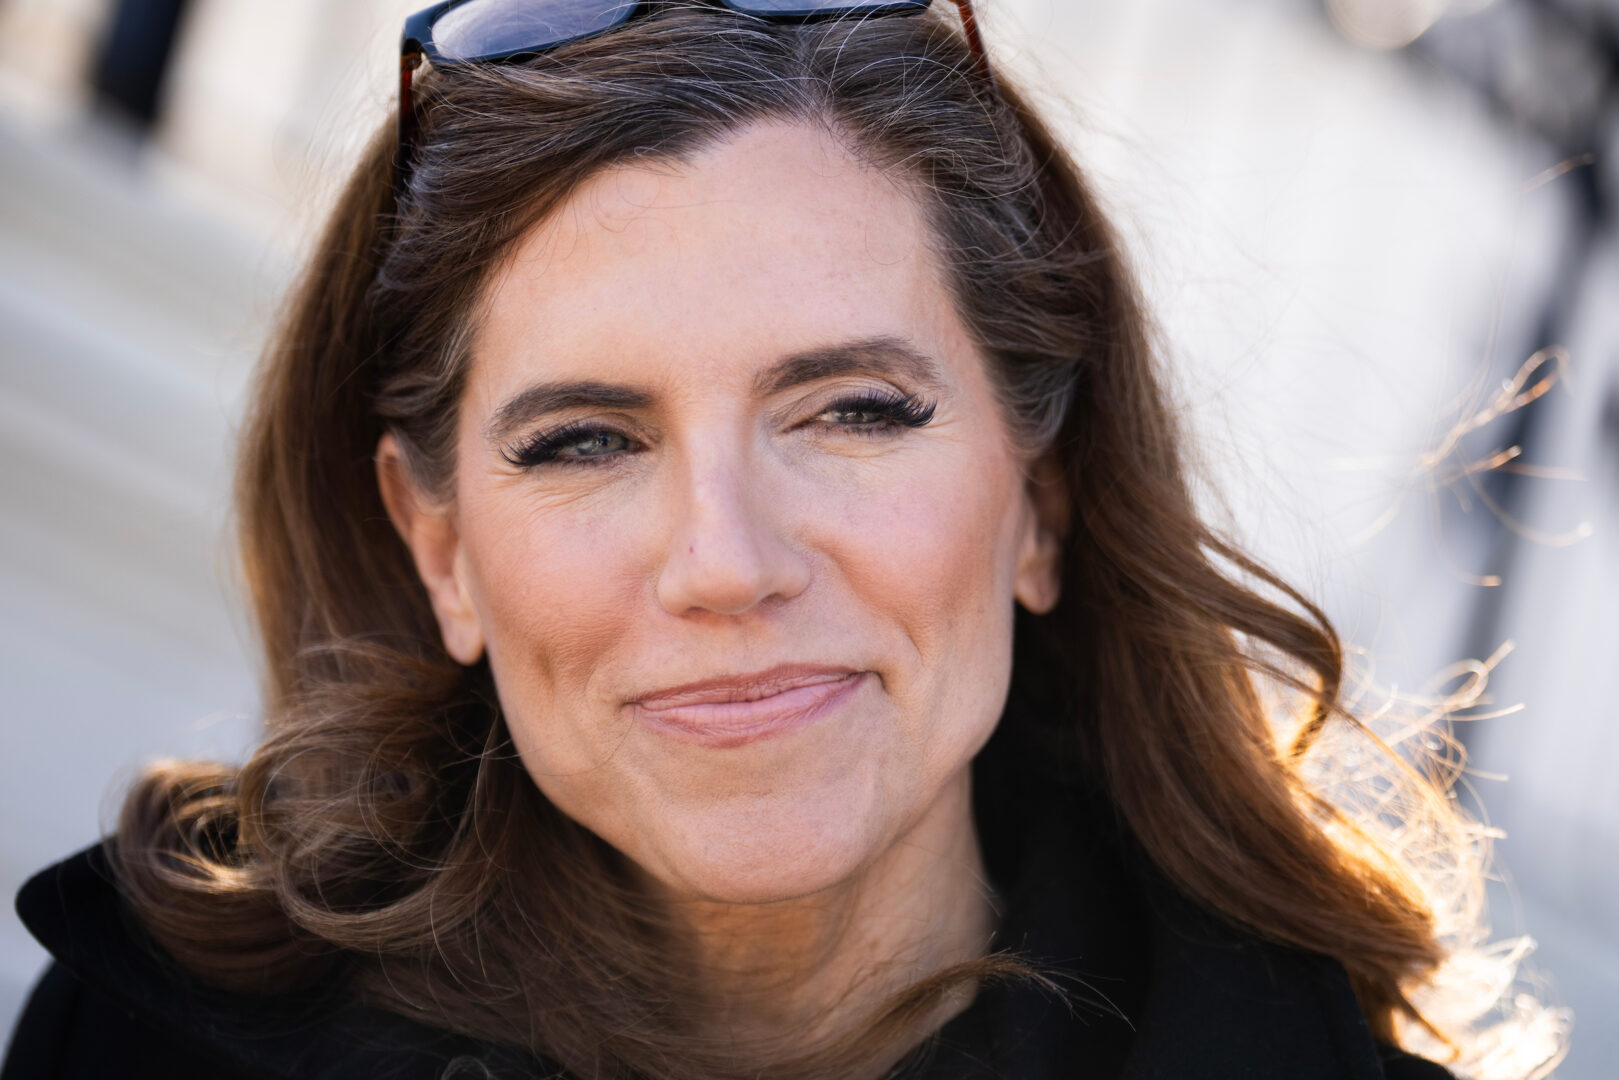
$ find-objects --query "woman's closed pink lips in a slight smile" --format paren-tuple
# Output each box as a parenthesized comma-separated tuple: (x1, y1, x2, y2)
(631, 665, 865, 748)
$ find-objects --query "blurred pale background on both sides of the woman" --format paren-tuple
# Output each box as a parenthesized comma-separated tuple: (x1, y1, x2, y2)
(0, 0, 1619, 1080)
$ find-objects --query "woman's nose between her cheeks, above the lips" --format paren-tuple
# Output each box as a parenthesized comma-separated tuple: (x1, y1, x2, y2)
(657, 460, 810, 615)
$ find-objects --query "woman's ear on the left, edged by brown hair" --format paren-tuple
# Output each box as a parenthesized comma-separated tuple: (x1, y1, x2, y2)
(377, 432, 484, 665)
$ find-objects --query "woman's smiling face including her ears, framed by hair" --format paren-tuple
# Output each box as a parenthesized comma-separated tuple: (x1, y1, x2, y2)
(379, 125, 1056, 902)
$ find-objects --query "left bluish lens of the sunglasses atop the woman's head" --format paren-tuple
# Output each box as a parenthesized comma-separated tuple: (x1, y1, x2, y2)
(432, 0, 637, 60)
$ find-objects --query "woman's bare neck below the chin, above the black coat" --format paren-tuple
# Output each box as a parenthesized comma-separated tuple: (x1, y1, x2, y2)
(663, 769, 994, 1064)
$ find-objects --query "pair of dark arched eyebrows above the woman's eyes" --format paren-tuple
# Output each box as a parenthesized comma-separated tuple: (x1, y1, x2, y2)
(484, 337, 945, 442)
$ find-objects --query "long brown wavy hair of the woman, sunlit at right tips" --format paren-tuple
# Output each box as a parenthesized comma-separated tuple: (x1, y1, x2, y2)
(115, 5, 1554, 1080)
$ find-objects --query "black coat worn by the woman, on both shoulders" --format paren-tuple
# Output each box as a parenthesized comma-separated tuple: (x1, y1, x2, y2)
(0, 718, 1451, 1080)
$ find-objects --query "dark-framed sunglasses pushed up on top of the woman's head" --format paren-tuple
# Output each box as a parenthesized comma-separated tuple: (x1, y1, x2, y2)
(393, 0, 991, 191)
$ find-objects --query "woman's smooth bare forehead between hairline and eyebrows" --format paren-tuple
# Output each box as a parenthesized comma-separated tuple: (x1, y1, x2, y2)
(474, 123, 957, 396)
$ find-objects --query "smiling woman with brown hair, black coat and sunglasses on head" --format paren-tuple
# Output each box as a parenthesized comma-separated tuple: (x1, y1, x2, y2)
(8, 0, 1567, 1080)
